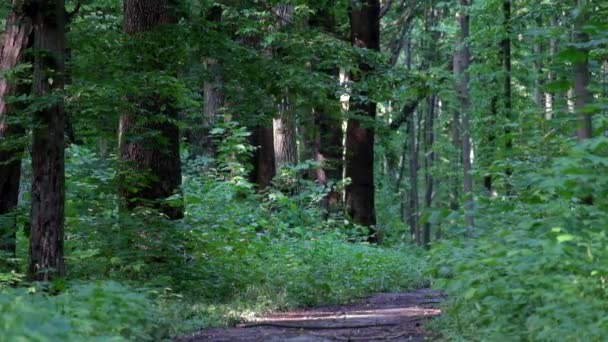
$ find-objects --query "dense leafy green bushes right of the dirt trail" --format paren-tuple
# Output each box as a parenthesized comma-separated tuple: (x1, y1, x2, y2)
(432, 137, 608, 341)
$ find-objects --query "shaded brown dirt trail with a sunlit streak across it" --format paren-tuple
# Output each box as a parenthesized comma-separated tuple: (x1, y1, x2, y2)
(177, 289, 444, 342)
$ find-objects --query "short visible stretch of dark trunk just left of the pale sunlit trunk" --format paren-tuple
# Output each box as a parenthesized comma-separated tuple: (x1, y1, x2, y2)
(249, 125, 276, 189)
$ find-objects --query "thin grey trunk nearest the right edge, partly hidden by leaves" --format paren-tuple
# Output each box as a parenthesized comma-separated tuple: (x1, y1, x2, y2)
(574, 0, 593, 140)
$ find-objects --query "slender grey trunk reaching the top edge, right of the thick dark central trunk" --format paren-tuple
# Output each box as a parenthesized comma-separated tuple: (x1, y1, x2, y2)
(454, 0, 474, 234)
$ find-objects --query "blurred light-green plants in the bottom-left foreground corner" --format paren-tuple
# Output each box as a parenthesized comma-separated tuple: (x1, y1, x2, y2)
(0, 282, 162, 342)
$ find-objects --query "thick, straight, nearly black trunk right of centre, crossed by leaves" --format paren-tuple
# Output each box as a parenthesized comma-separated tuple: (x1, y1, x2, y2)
(346, 0, 380, 242)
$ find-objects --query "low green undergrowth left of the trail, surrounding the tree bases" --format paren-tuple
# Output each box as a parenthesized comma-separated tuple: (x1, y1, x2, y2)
(0, 146, 428, 341)
